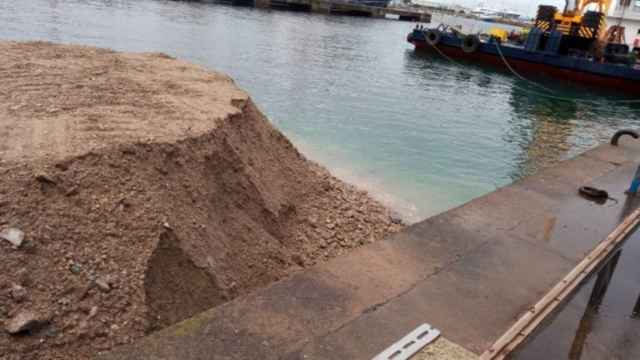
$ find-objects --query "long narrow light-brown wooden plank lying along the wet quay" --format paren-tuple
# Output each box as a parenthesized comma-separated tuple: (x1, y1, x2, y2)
(480, 209, 640, 360)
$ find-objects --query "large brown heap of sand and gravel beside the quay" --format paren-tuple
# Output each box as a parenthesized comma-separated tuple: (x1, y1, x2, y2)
(0, 42, 402, 359)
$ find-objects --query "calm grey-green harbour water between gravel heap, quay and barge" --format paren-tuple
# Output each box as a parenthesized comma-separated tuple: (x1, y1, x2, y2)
(0, 0, 640, 220)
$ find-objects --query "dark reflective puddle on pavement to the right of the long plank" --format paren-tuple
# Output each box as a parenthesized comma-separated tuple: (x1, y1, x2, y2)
(514, 231, 640, 360)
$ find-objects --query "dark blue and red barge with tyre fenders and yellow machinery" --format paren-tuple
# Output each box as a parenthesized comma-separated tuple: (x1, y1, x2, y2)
(407, 1, 640, 95)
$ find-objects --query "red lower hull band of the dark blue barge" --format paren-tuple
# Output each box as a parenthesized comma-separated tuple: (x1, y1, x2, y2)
(413, 42, 640, 95)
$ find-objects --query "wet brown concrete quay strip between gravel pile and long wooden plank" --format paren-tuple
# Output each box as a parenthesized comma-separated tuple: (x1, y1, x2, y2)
(103, 138, 640, 360)
